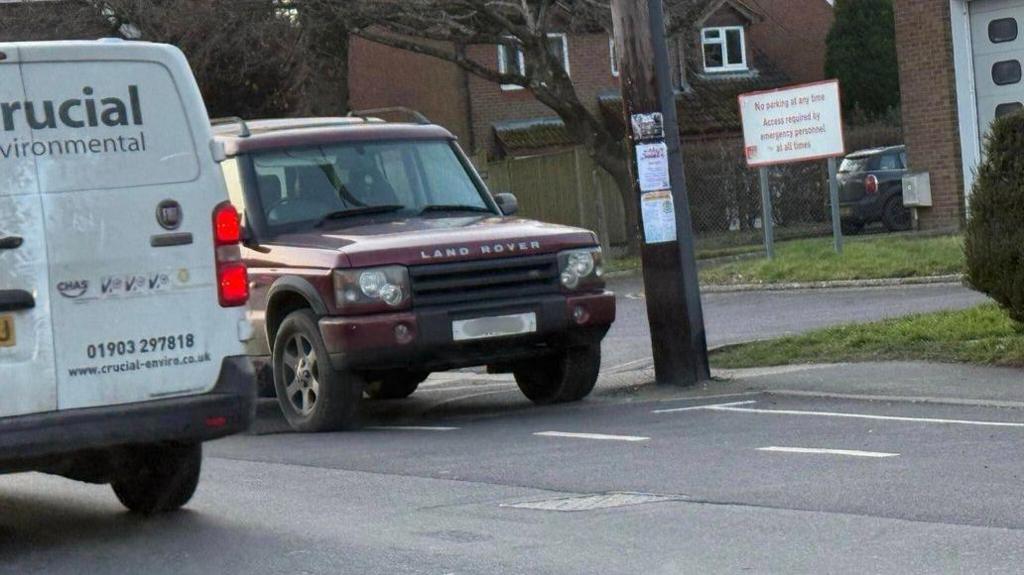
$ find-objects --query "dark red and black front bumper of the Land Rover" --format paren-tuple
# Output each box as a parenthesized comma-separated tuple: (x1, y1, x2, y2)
(319, 292, 615, 371)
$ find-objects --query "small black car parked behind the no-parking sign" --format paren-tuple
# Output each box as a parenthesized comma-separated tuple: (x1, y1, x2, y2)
(839, 145, 912, 233)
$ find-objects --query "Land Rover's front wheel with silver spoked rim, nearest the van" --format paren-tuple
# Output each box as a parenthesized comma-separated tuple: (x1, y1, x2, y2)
(273, 309, 364, 432)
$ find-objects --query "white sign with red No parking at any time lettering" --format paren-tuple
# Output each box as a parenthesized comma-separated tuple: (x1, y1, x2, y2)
(739, 80, 846, 168)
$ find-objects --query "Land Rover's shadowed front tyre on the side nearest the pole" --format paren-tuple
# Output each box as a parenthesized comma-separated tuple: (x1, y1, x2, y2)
(512, 344, 601, 405)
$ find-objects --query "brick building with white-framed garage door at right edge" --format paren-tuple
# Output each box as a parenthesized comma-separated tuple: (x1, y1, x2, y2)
(895, 0, 1024, 229)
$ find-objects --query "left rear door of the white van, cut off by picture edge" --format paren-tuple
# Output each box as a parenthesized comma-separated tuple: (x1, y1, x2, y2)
(0, 44, 57, 417)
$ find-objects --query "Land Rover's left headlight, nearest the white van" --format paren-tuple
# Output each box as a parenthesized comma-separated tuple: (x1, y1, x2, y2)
(334, 266, 410, 313)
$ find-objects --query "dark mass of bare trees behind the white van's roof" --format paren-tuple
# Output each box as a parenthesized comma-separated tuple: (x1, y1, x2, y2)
(0, 0, 348, 118)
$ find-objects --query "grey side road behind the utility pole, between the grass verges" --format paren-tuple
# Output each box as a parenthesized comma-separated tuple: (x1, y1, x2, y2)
(603, 277, 985, 366)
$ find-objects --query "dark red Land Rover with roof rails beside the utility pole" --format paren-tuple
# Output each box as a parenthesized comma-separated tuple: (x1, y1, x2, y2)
(215, 118, 615, 431)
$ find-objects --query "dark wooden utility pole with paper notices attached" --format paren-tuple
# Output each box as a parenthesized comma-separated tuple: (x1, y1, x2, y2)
(611, 0, 711, 386)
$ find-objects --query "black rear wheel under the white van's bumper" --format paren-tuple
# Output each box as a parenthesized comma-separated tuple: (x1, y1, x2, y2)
(111, 443, 203, 515)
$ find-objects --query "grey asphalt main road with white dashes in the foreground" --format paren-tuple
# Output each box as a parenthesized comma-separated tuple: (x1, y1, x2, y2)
(6, 394, 1024, 575)
